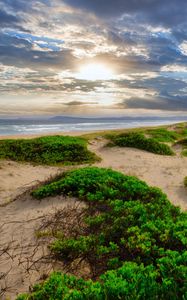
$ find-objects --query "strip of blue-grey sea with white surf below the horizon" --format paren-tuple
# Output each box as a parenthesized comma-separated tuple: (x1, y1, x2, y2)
(0, 116, 187, 136)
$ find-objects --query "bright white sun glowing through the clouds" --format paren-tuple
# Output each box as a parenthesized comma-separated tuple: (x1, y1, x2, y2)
(76, 63, 114, 81)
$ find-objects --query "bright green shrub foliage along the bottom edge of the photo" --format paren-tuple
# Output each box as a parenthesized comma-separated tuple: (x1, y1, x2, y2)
(17, 253, 187, 300)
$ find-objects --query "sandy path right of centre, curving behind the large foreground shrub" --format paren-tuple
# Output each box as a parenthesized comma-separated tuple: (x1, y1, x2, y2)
(90, 139, 187, 210)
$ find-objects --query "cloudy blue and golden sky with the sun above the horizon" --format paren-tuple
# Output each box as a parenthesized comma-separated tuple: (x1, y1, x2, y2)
(0, 0, 187, 116)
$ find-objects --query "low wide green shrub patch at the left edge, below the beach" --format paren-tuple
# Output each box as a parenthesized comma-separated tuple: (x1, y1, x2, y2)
(0, 136, 98, 165)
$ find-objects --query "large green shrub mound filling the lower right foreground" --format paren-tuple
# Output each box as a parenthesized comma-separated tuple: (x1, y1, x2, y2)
(17, 167, 187, 300)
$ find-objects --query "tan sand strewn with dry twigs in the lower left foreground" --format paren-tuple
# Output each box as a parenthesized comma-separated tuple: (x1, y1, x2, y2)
(0, 195, 79, 300)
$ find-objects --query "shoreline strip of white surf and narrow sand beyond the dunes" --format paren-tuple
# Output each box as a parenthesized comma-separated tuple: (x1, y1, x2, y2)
(0, 120, 186, 140)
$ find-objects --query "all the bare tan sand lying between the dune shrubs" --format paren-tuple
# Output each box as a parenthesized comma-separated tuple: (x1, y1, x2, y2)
(0, 134, 187, 300)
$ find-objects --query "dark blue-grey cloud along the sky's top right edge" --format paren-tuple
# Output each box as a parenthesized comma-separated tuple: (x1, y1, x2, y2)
(64, 0, 187, 25)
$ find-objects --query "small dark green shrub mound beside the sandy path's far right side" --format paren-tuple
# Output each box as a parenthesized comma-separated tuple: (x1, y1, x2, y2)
(108, 132, 174, 155)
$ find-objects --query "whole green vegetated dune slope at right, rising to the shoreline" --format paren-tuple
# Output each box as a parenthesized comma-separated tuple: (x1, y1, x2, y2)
(83, 122, 187, 156)
